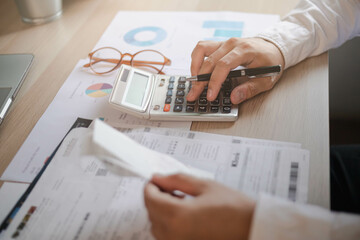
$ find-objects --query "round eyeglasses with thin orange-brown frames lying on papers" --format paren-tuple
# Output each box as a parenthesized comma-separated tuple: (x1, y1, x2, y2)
(83, 47, 171, 74)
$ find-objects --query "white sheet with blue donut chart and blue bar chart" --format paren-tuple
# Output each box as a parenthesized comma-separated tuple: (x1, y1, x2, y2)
(94, 11, 280, 75)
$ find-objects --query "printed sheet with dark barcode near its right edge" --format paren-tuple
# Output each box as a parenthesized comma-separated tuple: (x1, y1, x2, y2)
(121, 132, 310, 203)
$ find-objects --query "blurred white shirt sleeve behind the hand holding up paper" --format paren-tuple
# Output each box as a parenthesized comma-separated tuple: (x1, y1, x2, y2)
(250, 195, 360, 240)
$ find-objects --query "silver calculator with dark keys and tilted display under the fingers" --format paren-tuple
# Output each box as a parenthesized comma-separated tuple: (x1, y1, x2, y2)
(109, 64, 238, 121)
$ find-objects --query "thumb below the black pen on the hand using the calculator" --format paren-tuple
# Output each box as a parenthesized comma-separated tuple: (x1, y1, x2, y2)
(230, 77, 277, 104)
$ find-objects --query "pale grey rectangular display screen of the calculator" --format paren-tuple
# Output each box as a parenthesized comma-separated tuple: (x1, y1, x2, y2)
(125, 72, 149, 107)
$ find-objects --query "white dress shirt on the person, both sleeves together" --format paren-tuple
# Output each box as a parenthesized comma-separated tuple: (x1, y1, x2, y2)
(250, 0, 360, 240)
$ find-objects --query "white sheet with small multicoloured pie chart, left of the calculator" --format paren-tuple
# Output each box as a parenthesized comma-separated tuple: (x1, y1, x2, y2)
(1, 60, 191, 182)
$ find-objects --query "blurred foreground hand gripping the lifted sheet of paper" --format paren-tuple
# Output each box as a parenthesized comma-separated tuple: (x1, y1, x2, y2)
(144, 174, 255, 240)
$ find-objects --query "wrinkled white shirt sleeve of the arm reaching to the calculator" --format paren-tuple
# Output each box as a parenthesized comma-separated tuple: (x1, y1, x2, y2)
(258, 0, 360, 68)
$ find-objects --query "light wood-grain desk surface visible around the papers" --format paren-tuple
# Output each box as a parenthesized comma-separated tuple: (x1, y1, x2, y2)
(0, 0, 330, 207)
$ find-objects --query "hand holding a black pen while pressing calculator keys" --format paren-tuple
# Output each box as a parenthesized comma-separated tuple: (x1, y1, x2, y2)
(186, 38, 284, 104)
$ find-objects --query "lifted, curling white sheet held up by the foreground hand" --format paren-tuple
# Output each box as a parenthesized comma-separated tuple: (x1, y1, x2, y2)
(89, 120, 214, 180)
